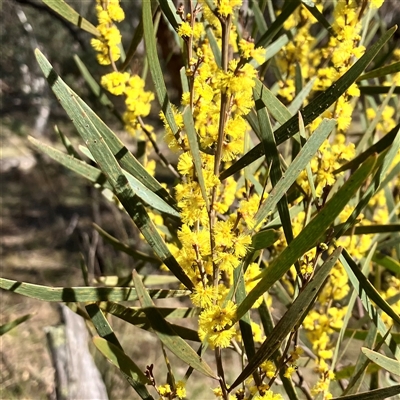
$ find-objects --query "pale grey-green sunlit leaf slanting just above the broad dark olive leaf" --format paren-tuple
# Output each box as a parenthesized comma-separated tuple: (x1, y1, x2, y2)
(255, 119, 336, 226)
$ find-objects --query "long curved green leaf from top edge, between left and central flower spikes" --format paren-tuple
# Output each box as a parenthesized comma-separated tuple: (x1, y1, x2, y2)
(142, 0, 178, 135)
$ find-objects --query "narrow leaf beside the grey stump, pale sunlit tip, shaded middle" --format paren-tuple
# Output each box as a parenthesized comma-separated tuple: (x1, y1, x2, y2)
(93, 337, 153, 400)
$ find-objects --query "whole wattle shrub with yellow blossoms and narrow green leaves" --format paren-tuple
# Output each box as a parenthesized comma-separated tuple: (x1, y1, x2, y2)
(0, 0, 400, 400)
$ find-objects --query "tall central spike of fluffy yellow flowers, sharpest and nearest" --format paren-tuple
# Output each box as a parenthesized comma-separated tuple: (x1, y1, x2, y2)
(166, 1, 264, 356)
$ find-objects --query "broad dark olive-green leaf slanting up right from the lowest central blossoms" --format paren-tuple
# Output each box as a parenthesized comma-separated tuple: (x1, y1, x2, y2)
(237, 153, 375, 318)
